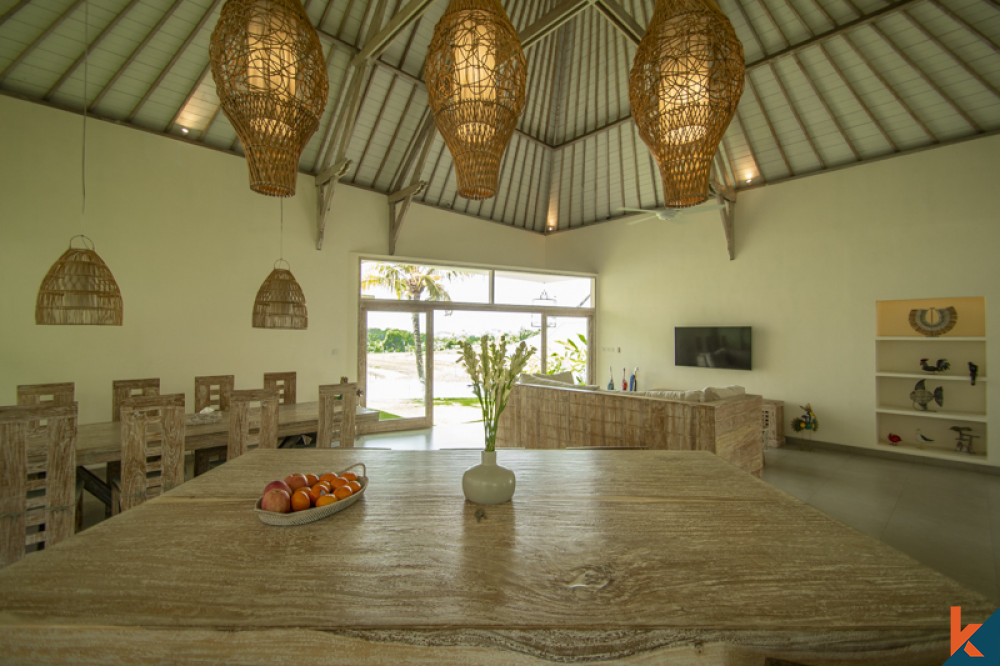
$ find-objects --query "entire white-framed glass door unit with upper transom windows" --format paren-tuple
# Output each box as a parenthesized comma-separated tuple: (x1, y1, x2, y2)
(358, 254, 594, 431)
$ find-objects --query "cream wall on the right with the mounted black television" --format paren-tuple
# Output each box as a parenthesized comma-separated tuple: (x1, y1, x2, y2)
(547, 137, 1000, 464)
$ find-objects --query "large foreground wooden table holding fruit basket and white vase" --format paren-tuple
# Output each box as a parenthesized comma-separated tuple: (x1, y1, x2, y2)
(0, 449, 995, 666)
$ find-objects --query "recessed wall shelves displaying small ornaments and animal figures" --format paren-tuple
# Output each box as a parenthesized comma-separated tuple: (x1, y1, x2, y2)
(875, 298, 989, 463)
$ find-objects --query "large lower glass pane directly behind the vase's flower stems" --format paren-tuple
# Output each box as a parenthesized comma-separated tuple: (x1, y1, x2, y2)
(434, 311, 541, 425)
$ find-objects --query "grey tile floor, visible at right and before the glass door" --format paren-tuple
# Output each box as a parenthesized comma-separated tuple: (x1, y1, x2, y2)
(84, 423, 1000, 605)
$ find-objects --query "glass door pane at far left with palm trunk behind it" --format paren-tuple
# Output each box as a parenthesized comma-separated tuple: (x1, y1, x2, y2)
(365, 312, 427, 420)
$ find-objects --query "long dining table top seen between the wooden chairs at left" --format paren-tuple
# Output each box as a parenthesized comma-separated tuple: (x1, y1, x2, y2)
(66, 402, 378, 465)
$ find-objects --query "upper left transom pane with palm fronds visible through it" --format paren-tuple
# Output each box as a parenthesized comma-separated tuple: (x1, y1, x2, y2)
(361, 260, 490, 303)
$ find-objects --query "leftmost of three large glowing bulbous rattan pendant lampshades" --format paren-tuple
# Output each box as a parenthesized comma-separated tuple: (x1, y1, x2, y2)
(209, 0, 329, 197)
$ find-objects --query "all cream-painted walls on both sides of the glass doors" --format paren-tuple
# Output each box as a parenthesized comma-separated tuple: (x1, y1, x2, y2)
(0, 96, 1000, 464)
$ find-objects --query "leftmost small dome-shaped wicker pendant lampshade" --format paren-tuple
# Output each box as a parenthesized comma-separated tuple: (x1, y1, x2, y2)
(35, 236, 123, 326)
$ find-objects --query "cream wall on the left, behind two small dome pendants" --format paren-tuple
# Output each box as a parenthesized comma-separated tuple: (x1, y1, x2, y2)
(0, 96, 545, 423)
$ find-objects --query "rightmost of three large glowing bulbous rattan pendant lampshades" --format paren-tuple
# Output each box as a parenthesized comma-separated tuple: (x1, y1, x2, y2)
(629, 0, 745, 208)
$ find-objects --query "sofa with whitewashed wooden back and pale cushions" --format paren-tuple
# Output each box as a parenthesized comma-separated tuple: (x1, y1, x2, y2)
(497, 377, 764, 477)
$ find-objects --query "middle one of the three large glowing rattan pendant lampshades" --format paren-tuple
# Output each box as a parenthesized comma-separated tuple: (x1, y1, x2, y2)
(424, 0, 527, 199)
